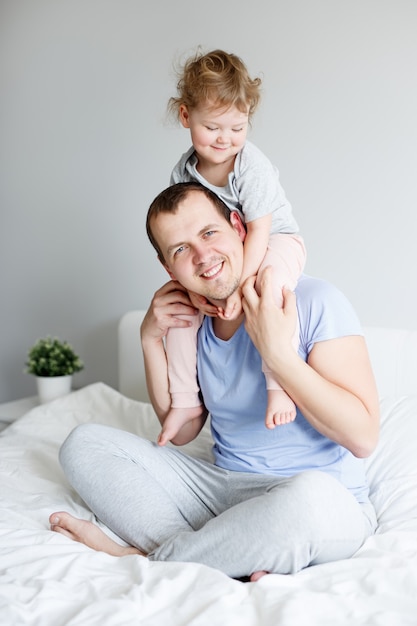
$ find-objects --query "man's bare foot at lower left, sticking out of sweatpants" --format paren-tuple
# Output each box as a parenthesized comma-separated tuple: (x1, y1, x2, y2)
(49, 511, 146, 556)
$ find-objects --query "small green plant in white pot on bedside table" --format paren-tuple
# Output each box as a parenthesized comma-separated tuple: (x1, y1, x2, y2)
(25, 336, 84, 403)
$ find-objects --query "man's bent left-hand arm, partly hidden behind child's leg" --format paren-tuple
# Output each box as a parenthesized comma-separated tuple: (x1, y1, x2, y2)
(140, 281, 207, 445)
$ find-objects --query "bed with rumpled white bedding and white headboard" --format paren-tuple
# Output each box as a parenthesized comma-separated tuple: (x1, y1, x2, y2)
(0, 311, 417, 626)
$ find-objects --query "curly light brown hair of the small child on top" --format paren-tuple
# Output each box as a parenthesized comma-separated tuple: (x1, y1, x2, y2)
(168, 50, 262, 120)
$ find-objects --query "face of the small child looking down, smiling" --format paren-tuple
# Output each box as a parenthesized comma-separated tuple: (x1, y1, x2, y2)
(180, 105, 249, 165)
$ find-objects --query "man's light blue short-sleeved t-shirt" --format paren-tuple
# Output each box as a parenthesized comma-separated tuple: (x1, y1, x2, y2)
(197, 276, 368, 502)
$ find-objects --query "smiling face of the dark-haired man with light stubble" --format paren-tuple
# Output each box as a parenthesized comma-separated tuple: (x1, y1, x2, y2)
(151, 191, 245, 301)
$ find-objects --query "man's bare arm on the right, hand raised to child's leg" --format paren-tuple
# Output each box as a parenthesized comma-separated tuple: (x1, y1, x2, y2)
(243, 268, 379, 457)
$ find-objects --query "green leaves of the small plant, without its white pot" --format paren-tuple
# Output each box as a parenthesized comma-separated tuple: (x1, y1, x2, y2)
(25, 337, 84, 377)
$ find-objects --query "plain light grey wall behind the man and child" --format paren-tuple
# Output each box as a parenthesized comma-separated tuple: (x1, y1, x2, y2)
(0, 0, 417, 402)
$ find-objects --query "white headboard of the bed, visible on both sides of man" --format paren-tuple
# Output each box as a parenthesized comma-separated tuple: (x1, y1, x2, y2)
(118, 311, 417, 402)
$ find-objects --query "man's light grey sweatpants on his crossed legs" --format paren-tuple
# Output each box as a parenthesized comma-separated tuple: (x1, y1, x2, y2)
(60, 424, 375, 578)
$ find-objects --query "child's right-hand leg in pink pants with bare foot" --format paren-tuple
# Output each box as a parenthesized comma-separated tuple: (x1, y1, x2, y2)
(254, 234, 306, 428)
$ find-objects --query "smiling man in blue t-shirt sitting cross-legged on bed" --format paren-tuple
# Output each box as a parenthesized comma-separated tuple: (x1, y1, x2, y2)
(50, 183, 379, 581)
